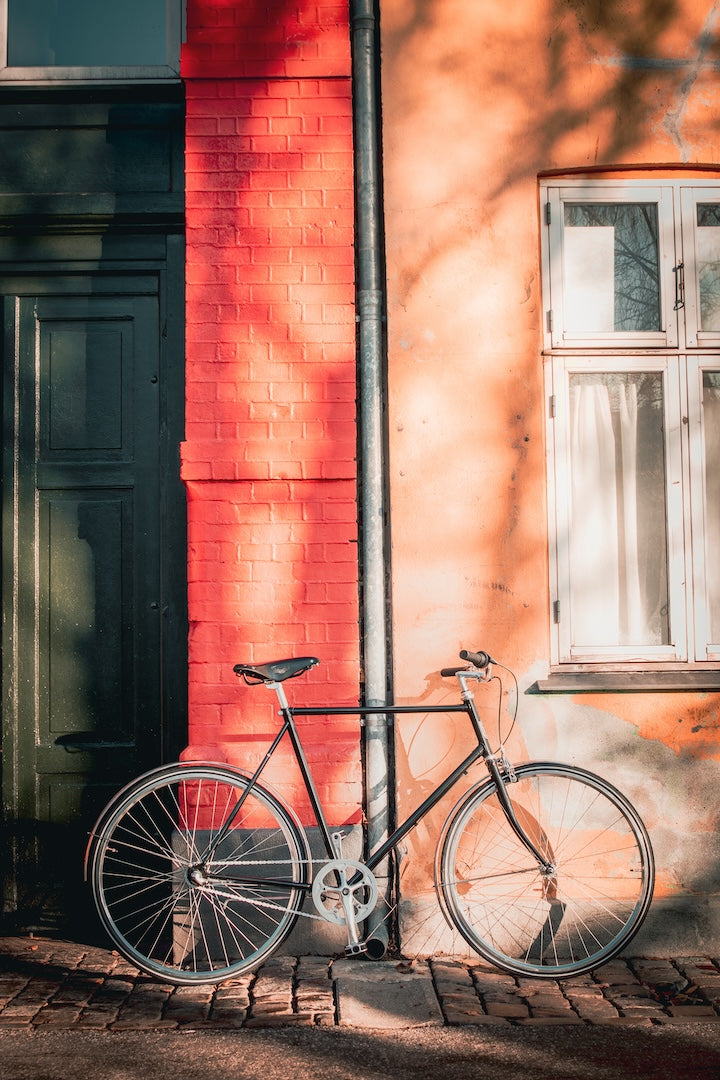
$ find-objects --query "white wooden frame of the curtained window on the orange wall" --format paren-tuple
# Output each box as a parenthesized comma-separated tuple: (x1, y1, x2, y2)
(540, 177, 720, 672)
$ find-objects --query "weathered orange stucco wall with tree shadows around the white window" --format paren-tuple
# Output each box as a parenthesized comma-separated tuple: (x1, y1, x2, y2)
(381, 0, 720, 946)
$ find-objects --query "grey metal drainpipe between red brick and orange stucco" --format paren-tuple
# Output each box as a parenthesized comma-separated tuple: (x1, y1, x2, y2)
(351, 0, 390, 958)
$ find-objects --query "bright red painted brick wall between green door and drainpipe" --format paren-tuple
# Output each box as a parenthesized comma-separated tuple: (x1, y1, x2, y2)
(182, 0, 362, 824)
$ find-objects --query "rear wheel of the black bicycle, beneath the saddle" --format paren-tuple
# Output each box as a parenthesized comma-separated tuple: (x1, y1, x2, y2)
(89, 764, 310, 985)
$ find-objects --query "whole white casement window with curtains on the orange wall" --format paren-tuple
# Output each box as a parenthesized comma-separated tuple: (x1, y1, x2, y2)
(541, 178, 720, 672)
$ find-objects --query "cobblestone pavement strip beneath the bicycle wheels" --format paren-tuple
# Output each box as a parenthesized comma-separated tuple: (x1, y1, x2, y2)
(0, 937, 720, 1031)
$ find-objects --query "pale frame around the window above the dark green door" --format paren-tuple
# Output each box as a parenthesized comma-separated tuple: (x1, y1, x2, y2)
(0, 0, 185, 84)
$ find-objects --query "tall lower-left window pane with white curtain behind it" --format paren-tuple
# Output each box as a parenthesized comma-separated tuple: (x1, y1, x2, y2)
(570, 373, 669, 647)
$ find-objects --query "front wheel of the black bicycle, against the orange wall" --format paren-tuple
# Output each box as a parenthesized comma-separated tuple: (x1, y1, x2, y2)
(436, 762, 654, 978)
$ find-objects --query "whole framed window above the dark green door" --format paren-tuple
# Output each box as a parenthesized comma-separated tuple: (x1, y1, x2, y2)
(0, 0, 184, 83)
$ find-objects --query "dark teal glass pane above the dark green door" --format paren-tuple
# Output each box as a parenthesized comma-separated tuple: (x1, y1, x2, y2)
(8, 0, 167, 67)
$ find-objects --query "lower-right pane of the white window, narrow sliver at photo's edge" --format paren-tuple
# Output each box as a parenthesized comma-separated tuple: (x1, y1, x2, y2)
(703, 372, 720, 645)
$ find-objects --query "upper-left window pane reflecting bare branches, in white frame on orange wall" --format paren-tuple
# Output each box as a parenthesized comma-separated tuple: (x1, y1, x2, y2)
(563, 203, 661, 334)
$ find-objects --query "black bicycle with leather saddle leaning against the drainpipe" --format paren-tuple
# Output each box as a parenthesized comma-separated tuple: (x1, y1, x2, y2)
(86, 650, 654, 984)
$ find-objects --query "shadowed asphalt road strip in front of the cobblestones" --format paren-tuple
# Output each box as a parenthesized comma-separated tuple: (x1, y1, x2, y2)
(0, 1023, 720, 1080)
